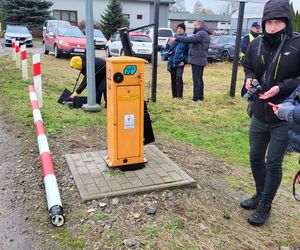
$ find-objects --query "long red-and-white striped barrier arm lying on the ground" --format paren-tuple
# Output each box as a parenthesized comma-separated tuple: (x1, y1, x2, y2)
(28, 85, 65, 227)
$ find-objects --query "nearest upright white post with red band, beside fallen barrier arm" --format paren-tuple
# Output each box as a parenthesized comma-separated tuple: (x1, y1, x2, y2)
(32, 54, 43, 108)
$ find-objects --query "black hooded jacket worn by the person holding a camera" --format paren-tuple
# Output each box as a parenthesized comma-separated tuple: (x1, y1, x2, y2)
(244, 0, 300, 123)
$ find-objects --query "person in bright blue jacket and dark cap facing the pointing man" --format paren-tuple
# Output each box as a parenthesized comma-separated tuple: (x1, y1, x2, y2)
(162, 23, 189, 98)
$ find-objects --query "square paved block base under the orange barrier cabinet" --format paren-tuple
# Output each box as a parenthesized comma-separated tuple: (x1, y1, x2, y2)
(65, 145, 196, 201)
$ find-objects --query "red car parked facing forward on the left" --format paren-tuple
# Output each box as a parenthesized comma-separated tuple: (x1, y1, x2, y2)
(43, 25, 86, 58)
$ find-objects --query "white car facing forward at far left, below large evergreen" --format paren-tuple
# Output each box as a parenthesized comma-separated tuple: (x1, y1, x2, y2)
(4, 25, 33, 47)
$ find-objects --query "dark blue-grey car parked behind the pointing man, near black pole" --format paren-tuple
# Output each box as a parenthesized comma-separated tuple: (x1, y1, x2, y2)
(208, 35, 236, 61)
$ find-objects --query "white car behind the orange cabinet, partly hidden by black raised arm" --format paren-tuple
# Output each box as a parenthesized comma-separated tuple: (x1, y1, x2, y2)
(105, 32, 152, 62)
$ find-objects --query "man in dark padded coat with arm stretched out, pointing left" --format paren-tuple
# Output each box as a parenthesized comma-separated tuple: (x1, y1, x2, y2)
(169, 20, 212, 102)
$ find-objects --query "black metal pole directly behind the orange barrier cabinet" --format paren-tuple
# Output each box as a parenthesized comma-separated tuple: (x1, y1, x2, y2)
(151, 0, 159, 102)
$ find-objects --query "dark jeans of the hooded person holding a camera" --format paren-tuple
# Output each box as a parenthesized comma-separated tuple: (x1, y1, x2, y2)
(249, 115, 289, 205)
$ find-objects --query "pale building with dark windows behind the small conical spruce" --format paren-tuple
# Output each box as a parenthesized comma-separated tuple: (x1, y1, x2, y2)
(50, 0, 174, 28)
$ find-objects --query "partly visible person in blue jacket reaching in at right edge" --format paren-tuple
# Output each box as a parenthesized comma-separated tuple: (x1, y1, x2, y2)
(273, 85, 300, 153)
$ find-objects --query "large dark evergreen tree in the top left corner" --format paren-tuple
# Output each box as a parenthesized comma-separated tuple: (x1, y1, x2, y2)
(2, 0, 53, 28)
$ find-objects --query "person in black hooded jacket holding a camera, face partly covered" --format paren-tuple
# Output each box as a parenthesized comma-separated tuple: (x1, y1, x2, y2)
(241, 0, 300, 226)
